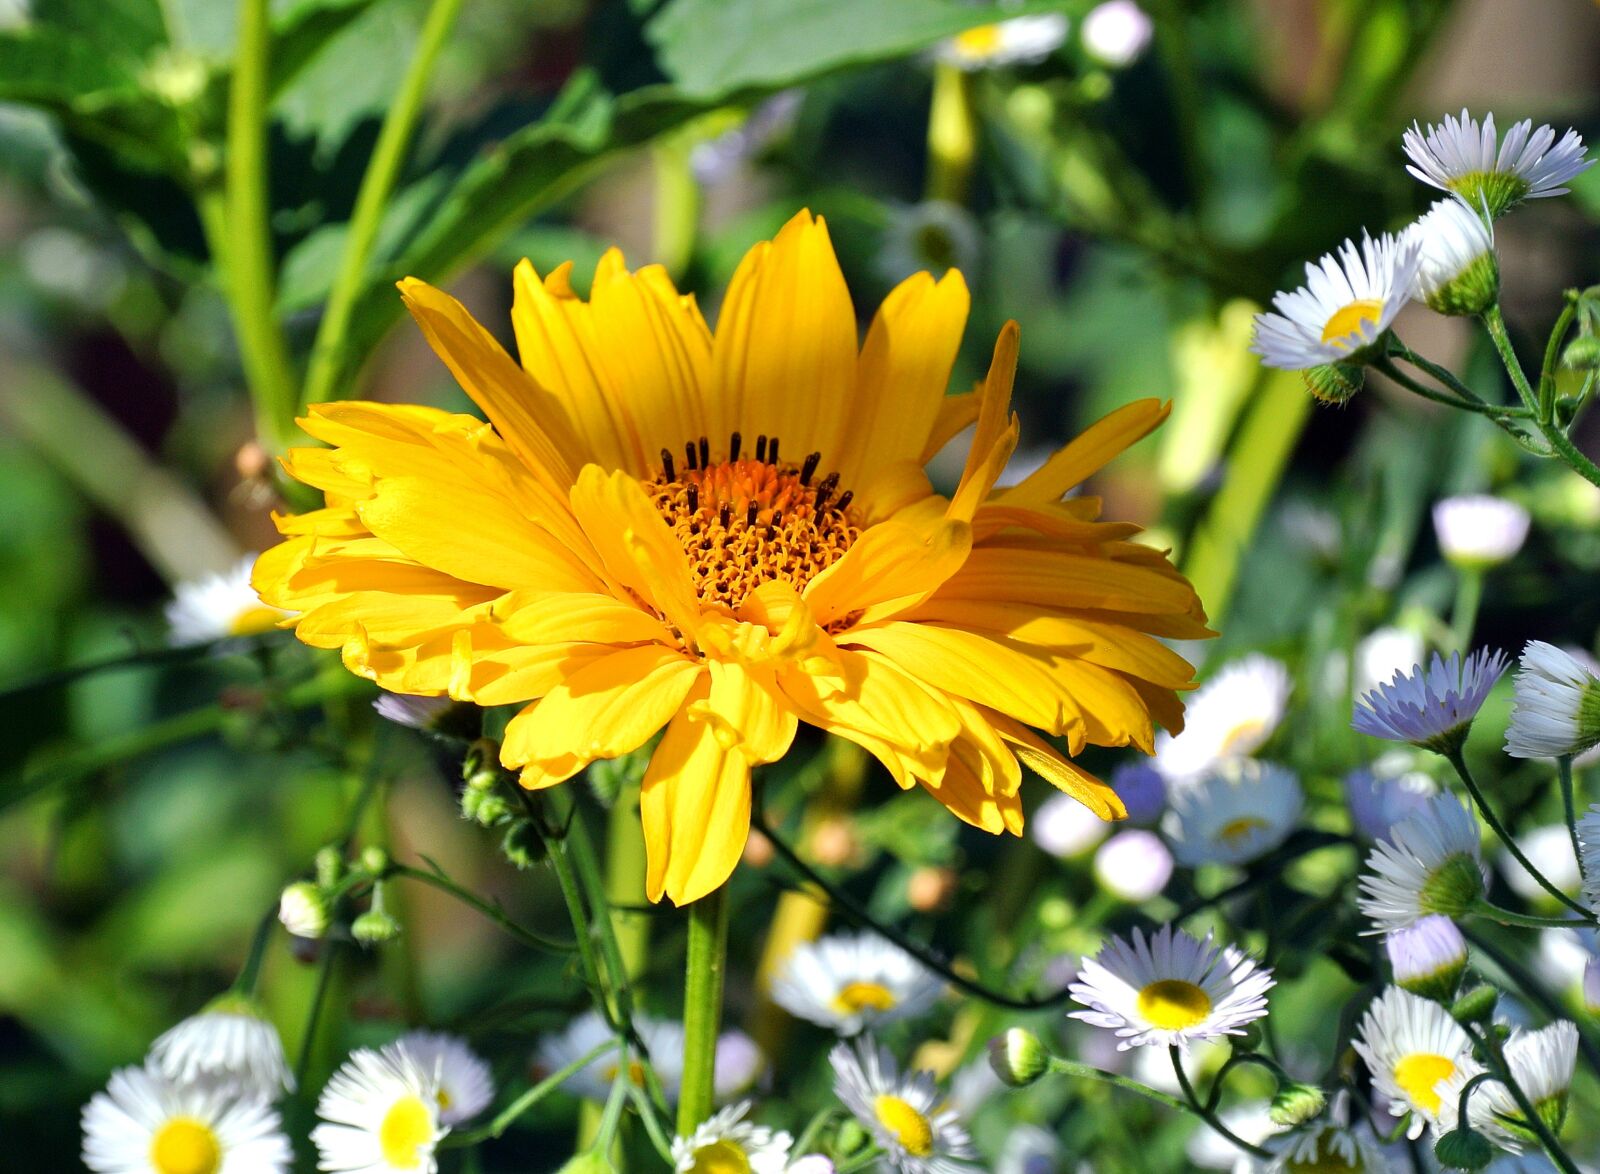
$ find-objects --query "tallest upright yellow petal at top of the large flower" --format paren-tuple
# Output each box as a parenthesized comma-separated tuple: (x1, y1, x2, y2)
(709, 211, 856, 469)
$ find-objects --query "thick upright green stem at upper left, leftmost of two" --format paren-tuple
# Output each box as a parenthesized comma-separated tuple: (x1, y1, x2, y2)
(224, 0, 296, 453)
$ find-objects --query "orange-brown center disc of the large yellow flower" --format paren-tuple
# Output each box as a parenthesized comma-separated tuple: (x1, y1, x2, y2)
(645, 432, 861, 611)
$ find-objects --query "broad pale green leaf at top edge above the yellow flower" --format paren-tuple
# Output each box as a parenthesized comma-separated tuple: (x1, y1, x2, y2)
(645, 0, 1066, 98)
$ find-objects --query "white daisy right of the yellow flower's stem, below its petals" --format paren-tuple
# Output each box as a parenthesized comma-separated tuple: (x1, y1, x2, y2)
(773, 931, 944, 1035)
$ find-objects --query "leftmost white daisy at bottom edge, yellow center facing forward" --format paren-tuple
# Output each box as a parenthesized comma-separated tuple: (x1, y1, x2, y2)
(83, 1068, 294, 1174)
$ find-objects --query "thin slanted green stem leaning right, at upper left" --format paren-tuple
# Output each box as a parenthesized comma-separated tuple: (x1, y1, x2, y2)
(299, 0, 461, 403)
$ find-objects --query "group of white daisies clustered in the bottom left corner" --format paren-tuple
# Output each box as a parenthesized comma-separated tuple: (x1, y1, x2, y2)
(83, 995, 494, 1174)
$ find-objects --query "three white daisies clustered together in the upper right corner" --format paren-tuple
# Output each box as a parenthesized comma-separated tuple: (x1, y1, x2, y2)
(1251, 110, 1594, 371)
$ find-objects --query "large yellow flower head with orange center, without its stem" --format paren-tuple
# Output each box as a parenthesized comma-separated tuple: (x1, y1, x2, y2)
(254, 213, 1210, 904)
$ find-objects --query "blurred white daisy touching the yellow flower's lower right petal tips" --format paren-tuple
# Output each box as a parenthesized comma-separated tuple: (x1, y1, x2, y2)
(1154, 653, 1290, 784)
